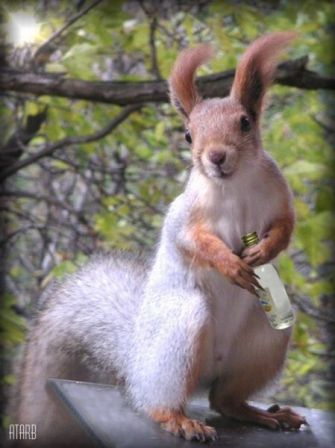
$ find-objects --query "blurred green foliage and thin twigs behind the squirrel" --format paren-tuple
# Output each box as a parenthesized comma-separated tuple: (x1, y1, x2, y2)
(0, 0, 335, 424)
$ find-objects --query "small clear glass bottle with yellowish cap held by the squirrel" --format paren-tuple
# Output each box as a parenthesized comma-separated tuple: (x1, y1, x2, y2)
(242, 232, 295, 330)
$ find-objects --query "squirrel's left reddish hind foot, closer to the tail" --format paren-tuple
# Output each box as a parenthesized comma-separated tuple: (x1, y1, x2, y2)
(150, 410, 217, 442)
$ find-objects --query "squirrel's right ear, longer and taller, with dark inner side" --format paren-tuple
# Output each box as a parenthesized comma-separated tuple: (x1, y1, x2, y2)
(230, 31, 297, 120)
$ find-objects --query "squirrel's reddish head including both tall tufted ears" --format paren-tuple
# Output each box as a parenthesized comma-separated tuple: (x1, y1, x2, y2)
(169, 32, 295, 182)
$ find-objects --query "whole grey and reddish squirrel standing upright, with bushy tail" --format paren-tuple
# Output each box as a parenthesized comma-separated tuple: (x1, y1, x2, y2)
(15, 32, 306, 446)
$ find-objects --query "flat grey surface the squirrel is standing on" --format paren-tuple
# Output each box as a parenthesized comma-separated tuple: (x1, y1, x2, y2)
(49, 379, 335, 448)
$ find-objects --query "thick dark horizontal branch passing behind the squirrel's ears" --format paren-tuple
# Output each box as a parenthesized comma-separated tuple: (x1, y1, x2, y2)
(0, 57, 335, 106)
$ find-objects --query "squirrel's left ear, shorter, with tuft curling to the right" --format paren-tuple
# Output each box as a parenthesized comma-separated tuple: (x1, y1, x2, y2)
(169, 44, 213, 117)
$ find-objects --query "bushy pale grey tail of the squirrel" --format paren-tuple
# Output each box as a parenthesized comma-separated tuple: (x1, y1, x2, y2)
(11, 255, 146, 447)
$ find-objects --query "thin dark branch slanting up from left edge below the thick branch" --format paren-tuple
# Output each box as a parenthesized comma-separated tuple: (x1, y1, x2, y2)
(0, 105, 141, 182)
